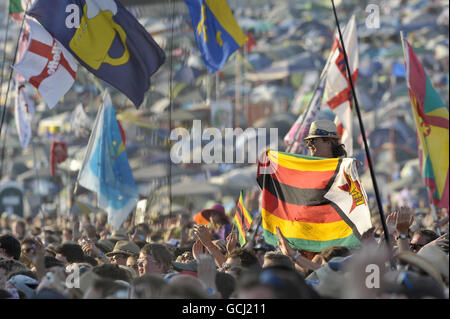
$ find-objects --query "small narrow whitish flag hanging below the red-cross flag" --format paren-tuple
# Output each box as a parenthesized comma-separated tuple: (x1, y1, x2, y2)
(14, 83, 35, 148)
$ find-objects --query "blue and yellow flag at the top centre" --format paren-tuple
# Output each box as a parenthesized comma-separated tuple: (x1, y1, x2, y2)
(185, 0, 247, 74)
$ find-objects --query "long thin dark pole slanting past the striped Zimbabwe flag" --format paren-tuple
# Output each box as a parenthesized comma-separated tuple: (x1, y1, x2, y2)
(331, 0, 392, 249)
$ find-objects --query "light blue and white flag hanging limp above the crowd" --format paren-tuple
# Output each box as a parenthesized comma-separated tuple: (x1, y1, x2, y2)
(78, 92, 139, 229)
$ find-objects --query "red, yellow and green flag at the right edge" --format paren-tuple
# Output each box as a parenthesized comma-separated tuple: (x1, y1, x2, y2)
(403, 40, 449, 209)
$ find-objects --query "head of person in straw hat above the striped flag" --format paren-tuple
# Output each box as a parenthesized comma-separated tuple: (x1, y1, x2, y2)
(304, 120, 347, 158)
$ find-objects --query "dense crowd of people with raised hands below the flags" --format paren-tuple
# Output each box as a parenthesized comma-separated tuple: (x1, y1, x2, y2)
(0, 191, 449, 299)
